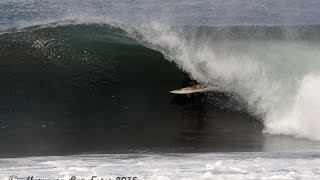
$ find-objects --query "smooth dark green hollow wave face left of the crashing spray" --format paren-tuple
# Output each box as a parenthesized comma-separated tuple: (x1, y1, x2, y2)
(0, 25, 270, 156)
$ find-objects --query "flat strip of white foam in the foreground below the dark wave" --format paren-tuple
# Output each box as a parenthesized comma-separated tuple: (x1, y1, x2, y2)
(0, 153, 320, 180)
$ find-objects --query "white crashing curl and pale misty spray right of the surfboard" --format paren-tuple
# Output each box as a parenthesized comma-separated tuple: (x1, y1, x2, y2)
(117, 23, 320, 140)
